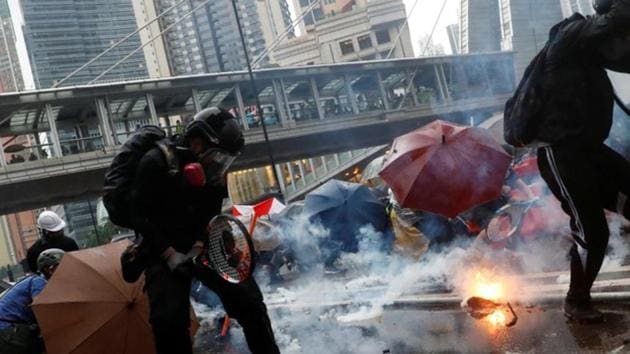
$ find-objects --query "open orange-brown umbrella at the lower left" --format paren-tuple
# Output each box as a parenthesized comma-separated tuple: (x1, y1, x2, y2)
(32, 240, 199, 354)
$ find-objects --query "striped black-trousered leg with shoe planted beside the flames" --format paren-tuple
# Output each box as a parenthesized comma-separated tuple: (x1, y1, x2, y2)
(538, 147, 609, 321)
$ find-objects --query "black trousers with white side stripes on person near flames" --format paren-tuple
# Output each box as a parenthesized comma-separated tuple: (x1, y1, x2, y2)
(538, 143, 630, 304)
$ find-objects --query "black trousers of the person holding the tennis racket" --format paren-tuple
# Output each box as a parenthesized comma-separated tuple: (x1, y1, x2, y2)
(145, 260, 280, 354)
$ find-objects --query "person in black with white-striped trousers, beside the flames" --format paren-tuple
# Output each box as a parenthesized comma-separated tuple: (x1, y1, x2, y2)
(536, 0, 630, 322)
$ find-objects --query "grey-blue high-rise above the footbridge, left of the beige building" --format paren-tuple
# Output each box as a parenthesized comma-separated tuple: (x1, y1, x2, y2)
(156, 0, 292, 75)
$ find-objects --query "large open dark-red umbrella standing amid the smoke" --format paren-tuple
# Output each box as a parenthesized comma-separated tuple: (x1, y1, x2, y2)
(380, 120, 511, 218)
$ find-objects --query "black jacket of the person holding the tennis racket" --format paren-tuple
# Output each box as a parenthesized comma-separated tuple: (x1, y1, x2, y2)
(132, 142, 227, 256)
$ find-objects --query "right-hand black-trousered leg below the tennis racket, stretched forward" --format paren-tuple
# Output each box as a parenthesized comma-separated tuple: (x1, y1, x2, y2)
(195, 267, 280, 354)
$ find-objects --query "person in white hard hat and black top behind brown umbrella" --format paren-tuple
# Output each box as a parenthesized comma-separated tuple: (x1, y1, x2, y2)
(26, 210, 79, 273)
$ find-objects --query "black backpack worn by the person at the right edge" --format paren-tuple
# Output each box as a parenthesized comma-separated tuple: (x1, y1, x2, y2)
(503, 44, 549, 147)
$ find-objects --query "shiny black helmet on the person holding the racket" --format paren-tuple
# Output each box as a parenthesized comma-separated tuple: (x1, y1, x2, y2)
(184, 107, 245, 154)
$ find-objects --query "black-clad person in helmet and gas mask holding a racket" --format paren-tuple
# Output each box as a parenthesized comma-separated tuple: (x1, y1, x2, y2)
(132, 107, 279, 354)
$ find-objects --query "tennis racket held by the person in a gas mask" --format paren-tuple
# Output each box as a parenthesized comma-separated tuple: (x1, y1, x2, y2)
(196, 214, 255, 284)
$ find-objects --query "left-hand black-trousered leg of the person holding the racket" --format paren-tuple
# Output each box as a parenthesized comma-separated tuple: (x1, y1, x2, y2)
(145, 261, 192, 354)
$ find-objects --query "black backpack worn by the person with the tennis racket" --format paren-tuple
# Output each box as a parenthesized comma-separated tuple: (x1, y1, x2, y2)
(103, 125, 179, 229)
